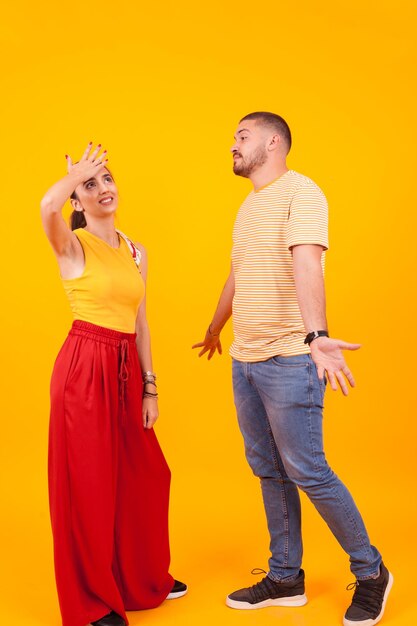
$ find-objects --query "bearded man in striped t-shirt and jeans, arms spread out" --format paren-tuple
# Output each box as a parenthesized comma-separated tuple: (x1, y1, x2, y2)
(193, 112, 393, 626)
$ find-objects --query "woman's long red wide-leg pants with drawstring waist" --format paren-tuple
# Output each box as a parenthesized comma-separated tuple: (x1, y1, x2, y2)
(49, 321, 174, 626)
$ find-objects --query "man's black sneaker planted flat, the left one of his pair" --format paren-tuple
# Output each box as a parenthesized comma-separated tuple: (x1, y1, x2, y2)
(226, 569, 307, 609)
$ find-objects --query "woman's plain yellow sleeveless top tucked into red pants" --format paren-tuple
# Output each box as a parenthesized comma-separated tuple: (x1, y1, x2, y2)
(62, 228, 145, 333)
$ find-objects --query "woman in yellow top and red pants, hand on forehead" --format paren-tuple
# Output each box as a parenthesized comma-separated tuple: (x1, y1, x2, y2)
(41, 143, 187, 626)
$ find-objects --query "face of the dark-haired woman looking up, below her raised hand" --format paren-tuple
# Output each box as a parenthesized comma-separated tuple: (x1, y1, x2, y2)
(73, 167, 119, 217)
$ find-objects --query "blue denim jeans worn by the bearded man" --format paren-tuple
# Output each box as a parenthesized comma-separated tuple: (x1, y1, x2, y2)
(233, 354, 381, 582)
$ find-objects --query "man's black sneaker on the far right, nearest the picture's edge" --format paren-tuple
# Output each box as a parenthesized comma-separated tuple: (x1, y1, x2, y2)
(343, 563, 394, 626)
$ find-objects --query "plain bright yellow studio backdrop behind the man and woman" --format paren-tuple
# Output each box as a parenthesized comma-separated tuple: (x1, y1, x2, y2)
(0, 0, 417, 626)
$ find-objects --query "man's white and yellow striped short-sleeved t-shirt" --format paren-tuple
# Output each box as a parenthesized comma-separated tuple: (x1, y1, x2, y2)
(230, 170, 328, 362)
